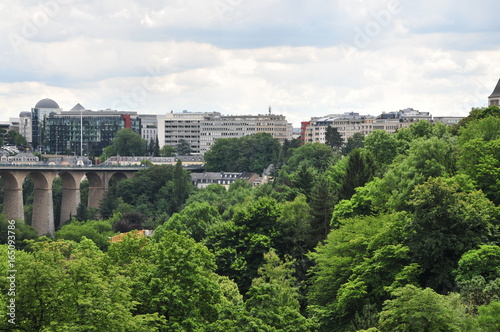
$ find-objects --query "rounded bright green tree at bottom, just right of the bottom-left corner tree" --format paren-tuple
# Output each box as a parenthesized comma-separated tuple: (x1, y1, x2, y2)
(132, 231, 223, 331)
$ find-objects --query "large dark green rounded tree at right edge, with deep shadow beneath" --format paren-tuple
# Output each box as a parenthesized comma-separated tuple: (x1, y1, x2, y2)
(405, 177, 498, 293)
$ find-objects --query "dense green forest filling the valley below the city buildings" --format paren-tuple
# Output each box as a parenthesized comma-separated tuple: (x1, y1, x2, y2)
(0, 106, 500, 332)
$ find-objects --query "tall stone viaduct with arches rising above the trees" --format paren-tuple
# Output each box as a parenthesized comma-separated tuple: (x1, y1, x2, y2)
(0, 166, 142, 235)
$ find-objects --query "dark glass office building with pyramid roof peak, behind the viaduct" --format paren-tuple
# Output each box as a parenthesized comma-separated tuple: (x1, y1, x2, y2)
(46, 104, 141, 156)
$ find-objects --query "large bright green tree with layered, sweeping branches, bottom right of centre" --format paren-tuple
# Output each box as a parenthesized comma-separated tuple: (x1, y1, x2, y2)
(307, 214, 418, 331)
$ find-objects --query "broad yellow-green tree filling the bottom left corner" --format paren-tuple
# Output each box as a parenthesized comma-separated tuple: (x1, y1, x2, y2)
(0, 239, 160, 332)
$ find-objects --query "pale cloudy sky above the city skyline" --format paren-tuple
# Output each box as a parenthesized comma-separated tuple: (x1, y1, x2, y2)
(0, 0, 500, 127)
